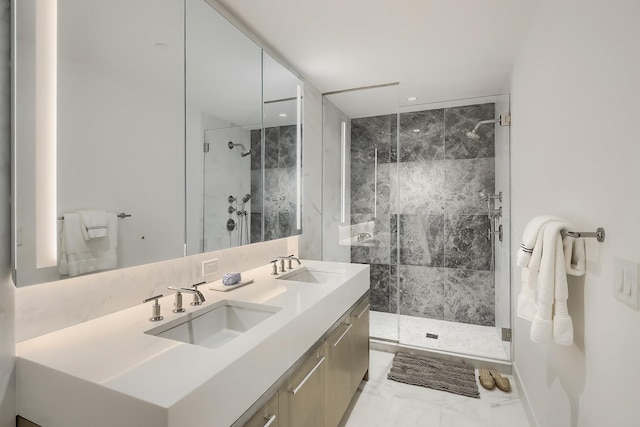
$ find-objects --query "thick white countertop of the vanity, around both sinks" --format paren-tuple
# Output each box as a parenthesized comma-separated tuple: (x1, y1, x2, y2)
(16, 260, 369, 427)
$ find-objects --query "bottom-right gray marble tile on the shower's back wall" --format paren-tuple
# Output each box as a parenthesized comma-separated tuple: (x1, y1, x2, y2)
(444, 269, 495, 326)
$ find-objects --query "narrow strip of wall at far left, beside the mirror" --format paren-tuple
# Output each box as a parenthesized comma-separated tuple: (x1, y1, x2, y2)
(0, 0, 16, 427)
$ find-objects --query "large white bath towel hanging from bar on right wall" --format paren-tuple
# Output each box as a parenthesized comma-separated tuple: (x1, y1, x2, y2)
(517, 217, 586, 345)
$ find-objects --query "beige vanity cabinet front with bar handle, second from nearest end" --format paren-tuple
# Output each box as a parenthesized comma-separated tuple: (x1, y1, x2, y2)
(280, 345, 326, 427)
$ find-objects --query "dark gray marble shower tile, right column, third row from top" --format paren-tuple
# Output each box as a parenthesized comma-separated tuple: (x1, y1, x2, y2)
(444, 214, 491, 270)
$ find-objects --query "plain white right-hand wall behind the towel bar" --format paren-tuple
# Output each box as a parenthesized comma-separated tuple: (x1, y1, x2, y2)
(511, 0, 640, 427)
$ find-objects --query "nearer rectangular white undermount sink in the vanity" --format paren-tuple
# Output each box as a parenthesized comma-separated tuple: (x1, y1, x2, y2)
(145, 300, 280, 348)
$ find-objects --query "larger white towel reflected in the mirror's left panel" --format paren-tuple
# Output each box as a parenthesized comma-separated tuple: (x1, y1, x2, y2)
(58, 212, 118, 276)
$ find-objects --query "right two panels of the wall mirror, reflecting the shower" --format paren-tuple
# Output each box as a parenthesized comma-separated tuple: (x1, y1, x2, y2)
(186, 0, 302, 254)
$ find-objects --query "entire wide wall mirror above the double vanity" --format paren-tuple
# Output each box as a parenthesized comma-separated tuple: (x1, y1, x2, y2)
(13, 0, 302, 286)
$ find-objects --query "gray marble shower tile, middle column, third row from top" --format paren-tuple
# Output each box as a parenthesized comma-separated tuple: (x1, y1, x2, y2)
(391, 215, 445, 267)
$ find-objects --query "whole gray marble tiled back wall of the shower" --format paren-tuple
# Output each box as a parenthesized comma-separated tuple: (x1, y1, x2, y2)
(351, 104, 495, 326)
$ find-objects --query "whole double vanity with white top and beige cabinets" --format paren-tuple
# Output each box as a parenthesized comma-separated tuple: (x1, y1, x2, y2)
(16, 260, 369, 427)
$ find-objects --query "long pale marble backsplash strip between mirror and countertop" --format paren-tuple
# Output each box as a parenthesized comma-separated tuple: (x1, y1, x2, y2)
(15, 236, 298, 342)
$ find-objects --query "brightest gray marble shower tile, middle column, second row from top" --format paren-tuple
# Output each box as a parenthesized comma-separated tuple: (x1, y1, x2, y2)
(389, 160, 445, 214)
